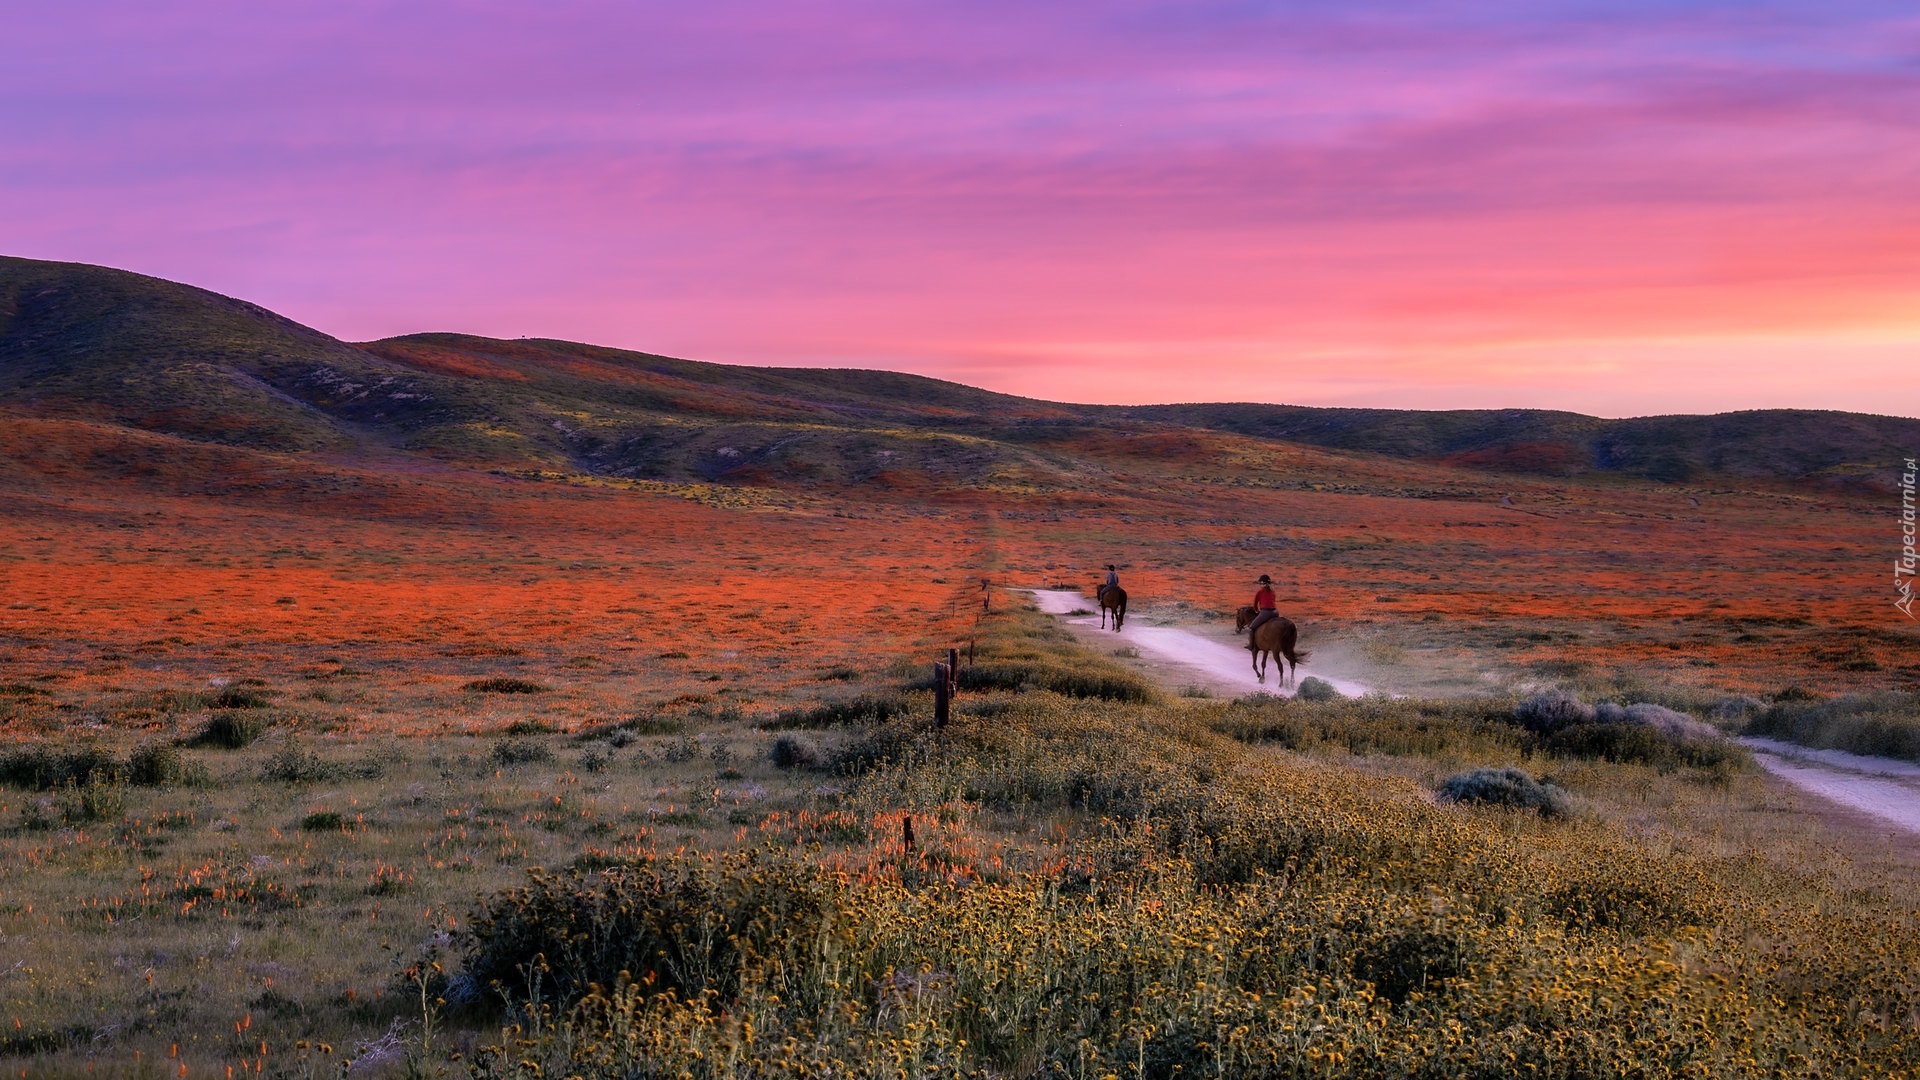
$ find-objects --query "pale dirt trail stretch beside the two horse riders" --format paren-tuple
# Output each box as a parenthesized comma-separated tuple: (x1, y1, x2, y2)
(1027, 588, 1373, 698)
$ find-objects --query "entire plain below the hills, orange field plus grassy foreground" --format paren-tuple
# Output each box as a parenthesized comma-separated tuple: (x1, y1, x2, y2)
(0, 405, 1920, 1080)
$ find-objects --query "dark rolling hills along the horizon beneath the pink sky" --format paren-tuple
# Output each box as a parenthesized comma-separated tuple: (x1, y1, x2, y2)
(0, 258, 1920, 484)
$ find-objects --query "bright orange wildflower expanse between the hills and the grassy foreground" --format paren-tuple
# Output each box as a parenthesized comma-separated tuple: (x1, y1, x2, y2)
(0, 411, 1889, 732)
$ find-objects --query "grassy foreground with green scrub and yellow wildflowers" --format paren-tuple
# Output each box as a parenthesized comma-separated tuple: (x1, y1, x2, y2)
(0, 609, 1920, 1076)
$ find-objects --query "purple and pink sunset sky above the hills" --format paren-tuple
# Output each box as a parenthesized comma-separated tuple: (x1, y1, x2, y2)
(0, 0, 1920, 417)
